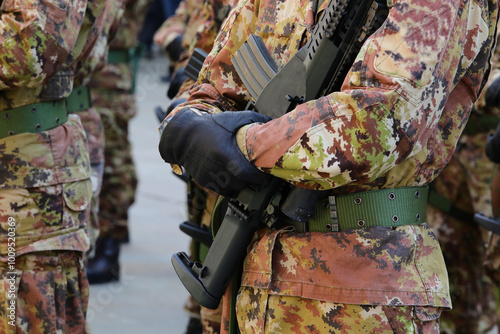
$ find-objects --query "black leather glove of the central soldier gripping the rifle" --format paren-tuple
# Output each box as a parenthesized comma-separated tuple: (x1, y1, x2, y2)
(159, 108, 272, 197)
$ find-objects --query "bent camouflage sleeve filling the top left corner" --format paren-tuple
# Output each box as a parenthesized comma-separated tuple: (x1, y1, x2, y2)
(0, 0, 87, 89)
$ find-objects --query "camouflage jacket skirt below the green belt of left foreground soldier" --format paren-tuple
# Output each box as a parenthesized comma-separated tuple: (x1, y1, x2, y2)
(0, 115, 92, 262)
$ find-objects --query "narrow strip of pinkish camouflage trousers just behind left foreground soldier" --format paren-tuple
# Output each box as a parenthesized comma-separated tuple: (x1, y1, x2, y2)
(78, 108, 104, 252)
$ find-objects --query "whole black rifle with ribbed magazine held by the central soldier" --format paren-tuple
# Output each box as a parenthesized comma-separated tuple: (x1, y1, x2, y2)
(172, 0, 388, 309)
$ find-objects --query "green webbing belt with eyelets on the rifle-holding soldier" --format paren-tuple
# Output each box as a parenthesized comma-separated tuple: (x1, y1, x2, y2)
(308, 187, 428, 232)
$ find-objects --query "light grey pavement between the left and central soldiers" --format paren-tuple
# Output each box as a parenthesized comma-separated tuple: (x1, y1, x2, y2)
(87, 55, 189, 334)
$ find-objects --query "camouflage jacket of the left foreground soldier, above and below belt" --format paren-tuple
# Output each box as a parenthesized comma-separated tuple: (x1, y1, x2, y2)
(0, 0, 110, 256)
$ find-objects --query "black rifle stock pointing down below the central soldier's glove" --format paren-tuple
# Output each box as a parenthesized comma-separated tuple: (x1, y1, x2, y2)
(172, 179, 280, 309)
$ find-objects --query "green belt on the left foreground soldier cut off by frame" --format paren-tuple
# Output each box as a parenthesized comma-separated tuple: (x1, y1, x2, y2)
(0, 100, 68, 138)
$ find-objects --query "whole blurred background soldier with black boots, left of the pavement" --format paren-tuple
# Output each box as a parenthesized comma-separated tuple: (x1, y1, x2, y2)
(87, 0, 149, 284)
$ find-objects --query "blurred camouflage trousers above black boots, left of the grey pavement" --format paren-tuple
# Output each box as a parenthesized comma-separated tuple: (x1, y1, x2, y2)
(92, 89, 137, 238)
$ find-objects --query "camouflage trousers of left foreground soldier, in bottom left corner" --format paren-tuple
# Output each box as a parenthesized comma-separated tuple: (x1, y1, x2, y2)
(0, 251, 89, 334)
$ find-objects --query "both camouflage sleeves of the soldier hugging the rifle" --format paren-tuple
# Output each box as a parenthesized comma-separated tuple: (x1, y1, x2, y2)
(164, 0, 497, 190)
